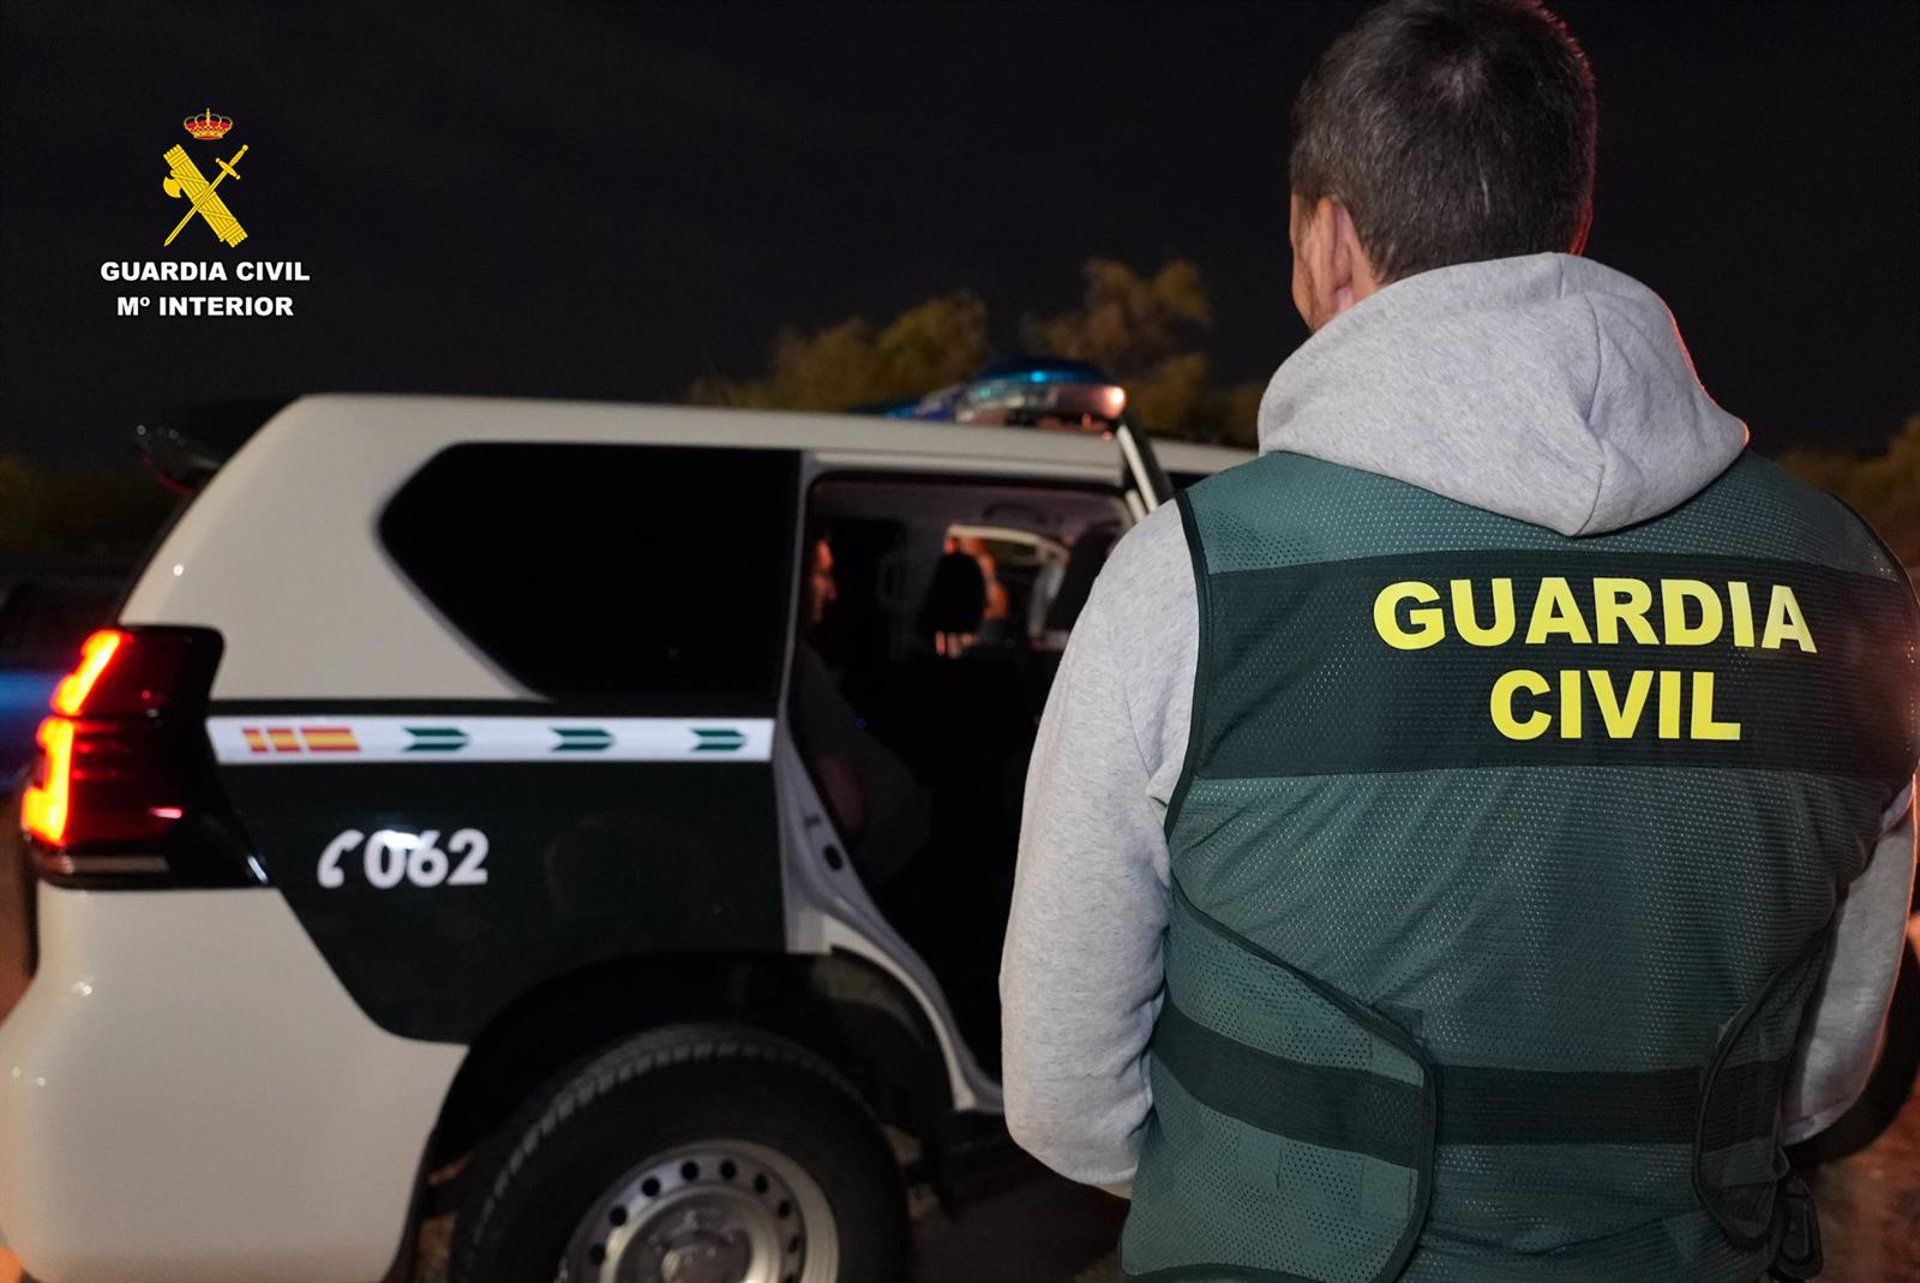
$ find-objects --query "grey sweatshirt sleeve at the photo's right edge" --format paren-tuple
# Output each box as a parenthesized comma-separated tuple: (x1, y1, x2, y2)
(1784, 784, 1914, 1145)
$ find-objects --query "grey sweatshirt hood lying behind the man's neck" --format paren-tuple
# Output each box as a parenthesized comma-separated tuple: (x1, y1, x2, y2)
(1260, 254, 1747, 534)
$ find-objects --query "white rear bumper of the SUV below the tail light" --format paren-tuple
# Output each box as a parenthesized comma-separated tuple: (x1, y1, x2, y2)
(0, 885, 465, 1283)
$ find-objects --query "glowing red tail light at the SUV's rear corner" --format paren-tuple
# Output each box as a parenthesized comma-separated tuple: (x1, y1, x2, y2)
(21, 628, 249, 884)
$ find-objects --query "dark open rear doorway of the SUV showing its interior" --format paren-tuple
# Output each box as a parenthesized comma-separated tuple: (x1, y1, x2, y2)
(789, 478, 1123, 1072)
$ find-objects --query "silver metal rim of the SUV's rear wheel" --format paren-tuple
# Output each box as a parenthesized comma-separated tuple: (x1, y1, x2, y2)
(557, 1141, 839, 1283)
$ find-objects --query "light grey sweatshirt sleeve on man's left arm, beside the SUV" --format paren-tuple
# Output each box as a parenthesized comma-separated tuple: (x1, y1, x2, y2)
(1000, 505, 1198, 1185)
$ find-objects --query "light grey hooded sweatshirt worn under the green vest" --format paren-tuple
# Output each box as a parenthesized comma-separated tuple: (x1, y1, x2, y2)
(1000, 254, 1914, 1187)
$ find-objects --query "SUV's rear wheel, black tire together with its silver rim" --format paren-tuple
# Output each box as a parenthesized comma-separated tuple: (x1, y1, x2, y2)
(449, 1026, 910, 1283)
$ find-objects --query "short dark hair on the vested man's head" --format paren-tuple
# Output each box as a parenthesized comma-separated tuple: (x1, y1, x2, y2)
(1288, 0, 1597, 280)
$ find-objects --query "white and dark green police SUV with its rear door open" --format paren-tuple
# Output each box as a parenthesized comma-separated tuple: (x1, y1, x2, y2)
(0, 387, 1244, 1283)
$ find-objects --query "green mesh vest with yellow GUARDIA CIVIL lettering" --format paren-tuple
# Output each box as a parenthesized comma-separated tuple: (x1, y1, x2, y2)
(1123, 453, 1920, 1283)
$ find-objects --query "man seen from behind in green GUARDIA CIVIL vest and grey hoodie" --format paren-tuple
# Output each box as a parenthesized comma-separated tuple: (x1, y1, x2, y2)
(1002, 0, 1920, 1283)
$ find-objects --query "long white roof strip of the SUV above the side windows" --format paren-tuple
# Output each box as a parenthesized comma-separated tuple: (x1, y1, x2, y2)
(267, 392, 1252, 472)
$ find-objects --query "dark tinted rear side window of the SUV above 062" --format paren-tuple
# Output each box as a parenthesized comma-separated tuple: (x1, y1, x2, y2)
(380, 444, 799, 716)
